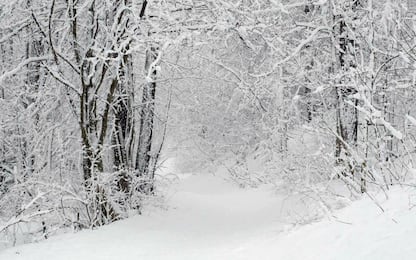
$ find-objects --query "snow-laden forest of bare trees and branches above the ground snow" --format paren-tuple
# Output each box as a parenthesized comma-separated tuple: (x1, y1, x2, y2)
(0, 0, 416, 259)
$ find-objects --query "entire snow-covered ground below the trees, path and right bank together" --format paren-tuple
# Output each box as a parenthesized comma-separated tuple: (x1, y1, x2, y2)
(0, 172, 416, 260)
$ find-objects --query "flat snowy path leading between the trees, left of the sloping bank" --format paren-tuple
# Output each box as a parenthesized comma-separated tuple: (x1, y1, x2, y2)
(0, 176, 292, 260)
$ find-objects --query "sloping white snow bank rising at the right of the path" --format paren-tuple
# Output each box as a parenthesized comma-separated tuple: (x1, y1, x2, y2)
(236, 188, 416, 260)
